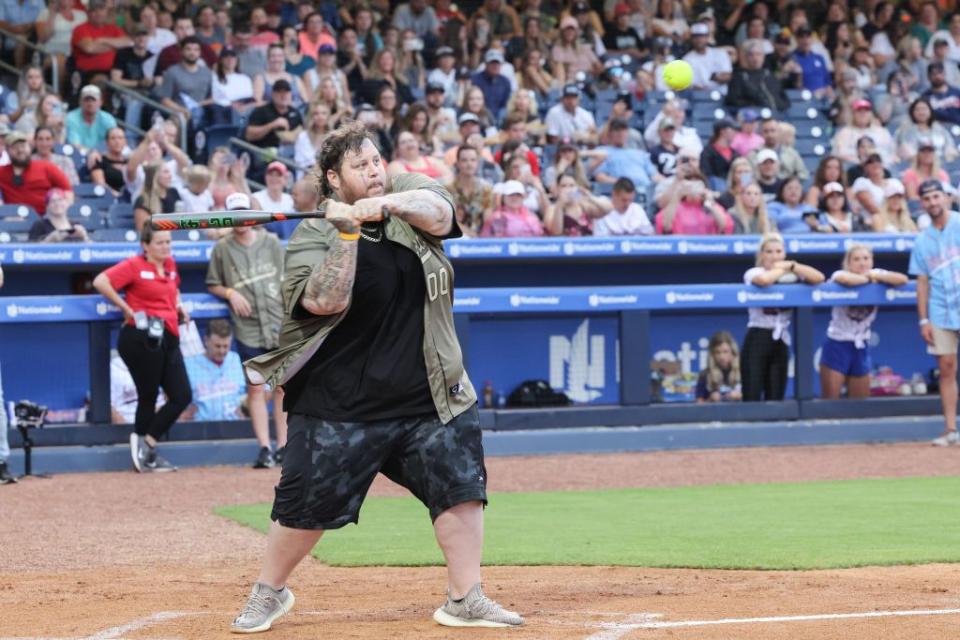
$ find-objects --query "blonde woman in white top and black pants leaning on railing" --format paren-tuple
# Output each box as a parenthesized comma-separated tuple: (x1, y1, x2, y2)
(740, 233, 824, 402)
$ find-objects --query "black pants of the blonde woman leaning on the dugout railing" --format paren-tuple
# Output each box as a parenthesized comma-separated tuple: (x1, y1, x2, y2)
(740, 327, 790, 402)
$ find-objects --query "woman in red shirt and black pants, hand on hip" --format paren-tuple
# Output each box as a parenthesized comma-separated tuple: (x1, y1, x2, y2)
(93, 225, 193, 473)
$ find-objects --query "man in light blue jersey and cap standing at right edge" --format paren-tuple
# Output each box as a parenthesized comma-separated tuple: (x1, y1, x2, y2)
(910, 180, 960, 446)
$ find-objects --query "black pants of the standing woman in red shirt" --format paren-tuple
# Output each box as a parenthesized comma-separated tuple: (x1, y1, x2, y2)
(117, 325, 193, 440)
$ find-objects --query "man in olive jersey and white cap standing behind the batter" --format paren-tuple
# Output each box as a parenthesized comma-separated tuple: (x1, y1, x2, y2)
(206, 195, 284, 468)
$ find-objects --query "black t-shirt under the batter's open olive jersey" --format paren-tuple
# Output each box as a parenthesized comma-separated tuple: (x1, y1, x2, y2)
(284, 224, 436, 422)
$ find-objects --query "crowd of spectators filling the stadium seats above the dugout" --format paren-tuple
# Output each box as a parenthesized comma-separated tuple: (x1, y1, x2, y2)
(0, 0, 960, 240)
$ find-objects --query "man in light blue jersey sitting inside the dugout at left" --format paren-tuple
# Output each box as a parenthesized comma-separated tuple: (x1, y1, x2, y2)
(182, 318, 246, 422)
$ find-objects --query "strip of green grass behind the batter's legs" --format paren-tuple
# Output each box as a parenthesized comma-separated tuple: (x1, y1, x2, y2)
(216, 477, 960, 569)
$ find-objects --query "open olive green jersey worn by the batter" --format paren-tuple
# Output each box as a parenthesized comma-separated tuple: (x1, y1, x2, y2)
(244, 173, 477, 424)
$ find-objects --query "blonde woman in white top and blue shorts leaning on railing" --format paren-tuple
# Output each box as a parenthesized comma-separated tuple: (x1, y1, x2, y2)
(820, 244, 908, 400)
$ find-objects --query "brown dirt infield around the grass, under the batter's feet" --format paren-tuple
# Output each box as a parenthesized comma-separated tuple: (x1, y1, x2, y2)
(0, 445, 960, 640)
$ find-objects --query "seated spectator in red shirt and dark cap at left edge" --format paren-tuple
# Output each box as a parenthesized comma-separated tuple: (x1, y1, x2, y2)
(0, 131, 73, 215)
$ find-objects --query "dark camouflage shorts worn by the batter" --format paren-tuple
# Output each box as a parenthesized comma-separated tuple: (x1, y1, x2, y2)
(270, 405, 487, 529)
